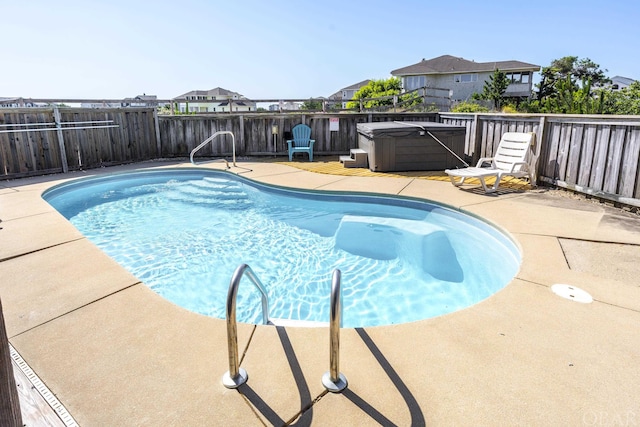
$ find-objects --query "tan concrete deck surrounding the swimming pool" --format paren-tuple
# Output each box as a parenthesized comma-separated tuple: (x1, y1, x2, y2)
(0, 161, 640, 426)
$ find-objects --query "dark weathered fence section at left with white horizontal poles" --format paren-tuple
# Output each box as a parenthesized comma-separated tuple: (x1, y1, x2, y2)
(0, 107, 159, 178)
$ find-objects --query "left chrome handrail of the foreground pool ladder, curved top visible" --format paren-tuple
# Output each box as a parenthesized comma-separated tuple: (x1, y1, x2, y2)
(222, 264, 269, 388)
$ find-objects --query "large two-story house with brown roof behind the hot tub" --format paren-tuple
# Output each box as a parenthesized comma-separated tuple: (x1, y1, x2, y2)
(391, 55, 540, 102)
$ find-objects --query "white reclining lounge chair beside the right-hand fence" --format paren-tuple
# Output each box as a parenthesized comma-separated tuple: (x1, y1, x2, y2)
(445, 132, 535, 193)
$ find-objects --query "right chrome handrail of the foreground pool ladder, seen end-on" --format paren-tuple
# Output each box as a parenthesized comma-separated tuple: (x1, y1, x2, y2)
(322, 269, 347, 393)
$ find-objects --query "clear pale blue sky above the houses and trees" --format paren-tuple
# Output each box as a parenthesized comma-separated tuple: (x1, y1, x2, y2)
(0, 0, 640, 99)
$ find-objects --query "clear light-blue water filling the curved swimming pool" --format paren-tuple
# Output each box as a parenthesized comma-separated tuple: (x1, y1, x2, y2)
(43, 168, 520, 327)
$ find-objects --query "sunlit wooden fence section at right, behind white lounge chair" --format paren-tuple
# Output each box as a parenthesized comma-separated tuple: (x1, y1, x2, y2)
(440, 113, 640, 207)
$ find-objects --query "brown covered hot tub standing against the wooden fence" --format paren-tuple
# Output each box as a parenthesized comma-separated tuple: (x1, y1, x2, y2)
(357, 122, 466, 172)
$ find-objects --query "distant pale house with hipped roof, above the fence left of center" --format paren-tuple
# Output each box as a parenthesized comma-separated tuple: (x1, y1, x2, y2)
(175, 87, 256, 113)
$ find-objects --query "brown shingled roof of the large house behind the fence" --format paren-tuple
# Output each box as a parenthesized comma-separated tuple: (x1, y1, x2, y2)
(391, 55, 540, 76)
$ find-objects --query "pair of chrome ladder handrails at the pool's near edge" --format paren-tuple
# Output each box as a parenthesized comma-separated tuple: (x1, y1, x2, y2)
(222, 264, 347, 393)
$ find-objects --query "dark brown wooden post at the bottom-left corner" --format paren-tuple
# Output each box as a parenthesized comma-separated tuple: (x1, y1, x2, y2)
(0, 301, 23, 427)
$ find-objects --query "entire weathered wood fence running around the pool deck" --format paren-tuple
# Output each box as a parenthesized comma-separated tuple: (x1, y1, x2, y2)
(0, 108, 640, 206)
